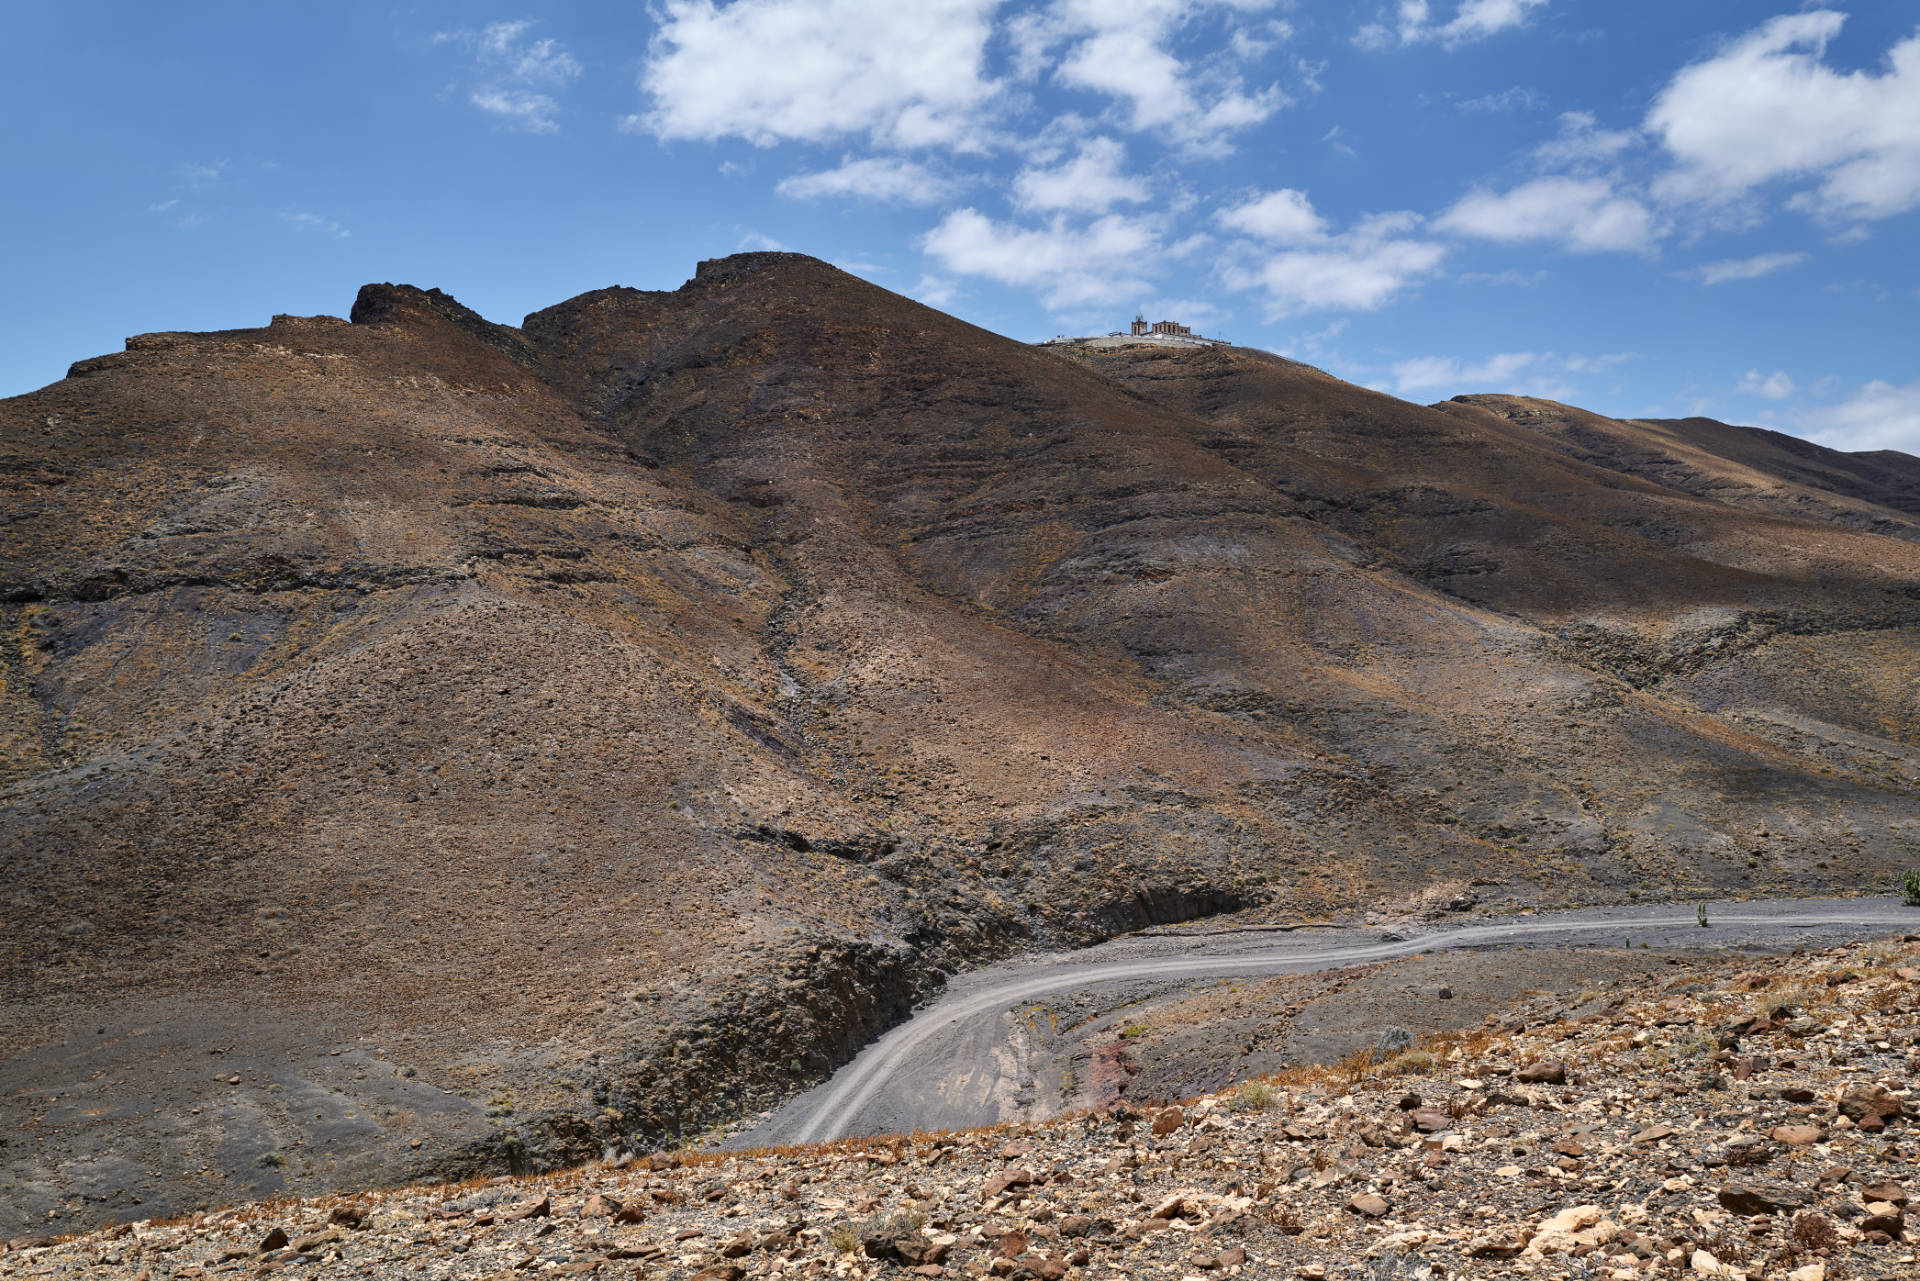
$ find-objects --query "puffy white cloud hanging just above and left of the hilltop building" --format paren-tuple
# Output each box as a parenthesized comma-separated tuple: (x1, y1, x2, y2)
(922, 209, 1162, 309)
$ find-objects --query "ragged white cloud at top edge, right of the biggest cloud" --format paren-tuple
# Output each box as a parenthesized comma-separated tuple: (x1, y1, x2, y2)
(1008, 0, 1288, 154)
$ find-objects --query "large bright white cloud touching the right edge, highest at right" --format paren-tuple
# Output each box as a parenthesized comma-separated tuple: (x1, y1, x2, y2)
(1647, 10, 1920, 219)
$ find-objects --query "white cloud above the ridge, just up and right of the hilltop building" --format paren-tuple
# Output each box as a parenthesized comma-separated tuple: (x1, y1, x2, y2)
(1221, 202, 1446, 321)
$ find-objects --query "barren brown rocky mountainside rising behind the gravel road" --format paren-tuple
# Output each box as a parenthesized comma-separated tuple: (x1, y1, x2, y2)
(0, 255, 1920, 1221)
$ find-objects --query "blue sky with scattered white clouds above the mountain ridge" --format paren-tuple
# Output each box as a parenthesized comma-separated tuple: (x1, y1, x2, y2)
(0, 0, 1920, 453)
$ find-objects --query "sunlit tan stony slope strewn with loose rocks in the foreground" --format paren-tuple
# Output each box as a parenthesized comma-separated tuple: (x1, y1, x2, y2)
(0, 935, 1920, 1281)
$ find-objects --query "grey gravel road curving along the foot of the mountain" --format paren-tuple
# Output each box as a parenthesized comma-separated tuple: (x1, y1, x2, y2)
(730, 899, 1920, 1147)
